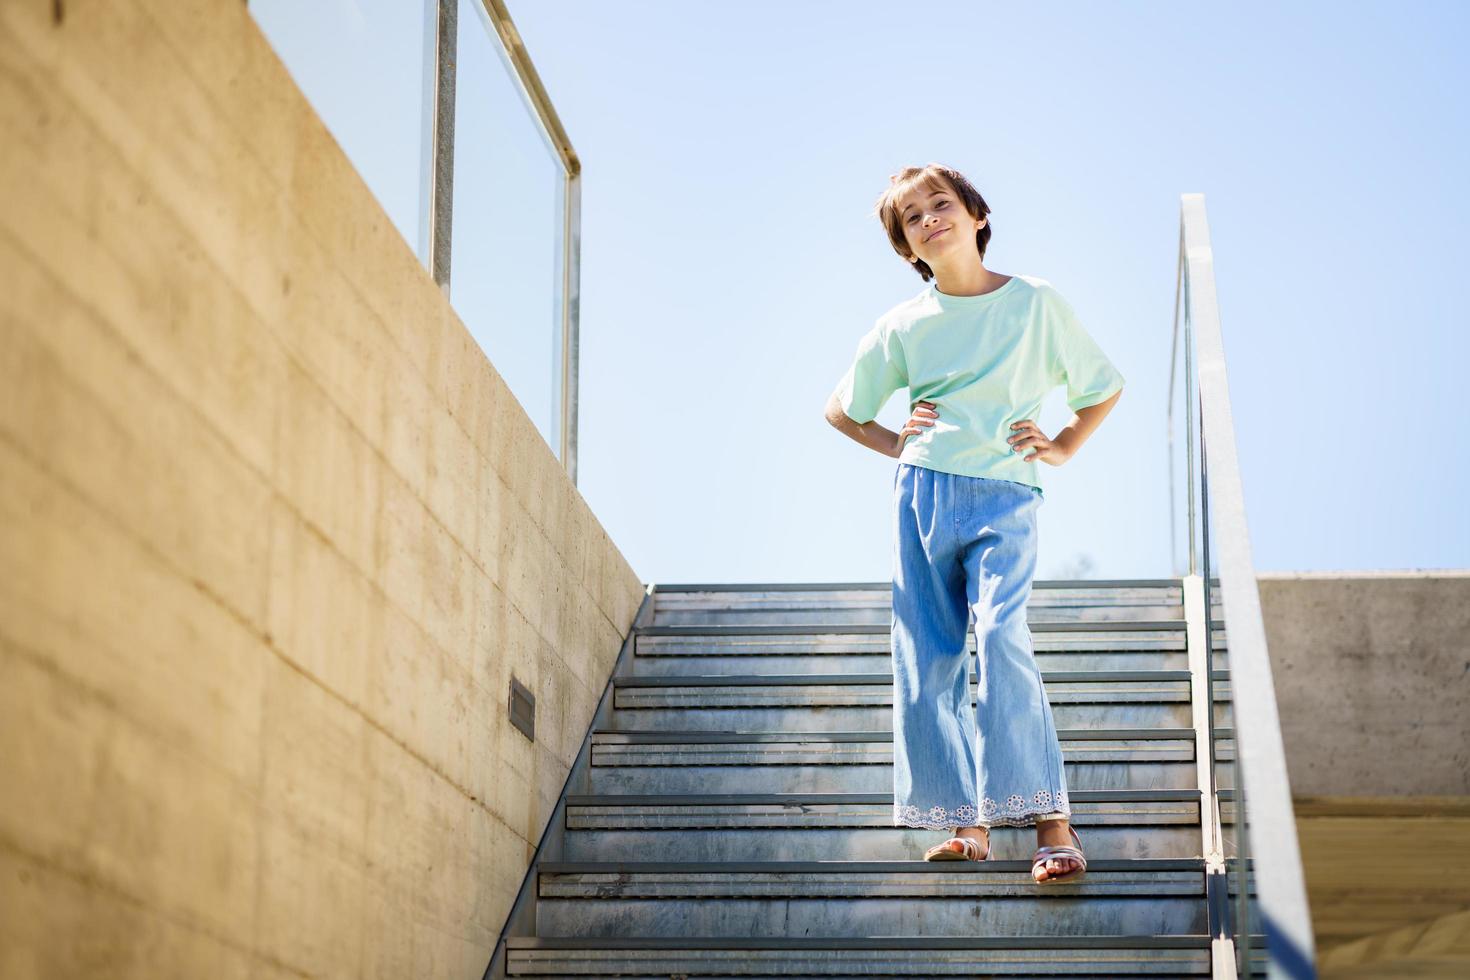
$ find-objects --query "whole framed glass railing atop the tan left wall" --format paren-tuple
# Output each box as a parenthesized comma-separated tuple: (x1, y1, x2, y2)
(250, 0, 581, 482)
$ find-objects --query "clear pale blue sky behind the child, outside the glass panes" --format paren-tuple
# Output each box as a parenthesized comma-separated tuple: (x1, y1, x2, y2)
(255, 0, 1470, 583)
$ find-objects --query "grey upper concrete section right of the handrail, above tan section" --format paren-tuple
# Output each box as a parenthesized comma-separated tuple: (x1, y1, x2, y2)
(1258, 572, 1470, 798)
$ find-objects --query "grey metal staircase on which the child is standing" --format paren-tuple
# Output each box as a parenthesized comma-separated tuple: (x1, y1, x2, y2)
(487, 577, 1270, 977)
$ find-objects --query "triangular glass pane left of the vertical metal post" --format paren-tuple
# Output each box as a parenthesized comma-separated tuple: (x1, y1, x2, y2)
(250, 0, 438, 266)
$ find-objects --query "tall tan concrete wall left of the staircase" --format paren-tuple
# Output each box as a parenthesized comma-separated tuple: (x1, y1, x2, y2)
(0, 0, 644, 977)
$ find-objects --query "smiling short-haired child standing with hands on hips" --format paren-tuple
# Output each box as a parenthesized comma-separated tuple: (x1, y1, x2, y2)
(828, 163, 1123, 883)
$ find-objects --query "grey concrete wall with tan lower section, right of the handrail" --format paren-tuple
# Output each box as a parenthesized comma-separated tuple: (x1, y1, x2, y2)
(1258, 572, 1470, 977)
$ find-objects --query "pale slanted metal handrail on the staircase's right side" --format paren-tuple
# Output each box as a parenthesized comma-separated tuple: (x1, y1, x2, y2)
(1169, 194, 1316, 979)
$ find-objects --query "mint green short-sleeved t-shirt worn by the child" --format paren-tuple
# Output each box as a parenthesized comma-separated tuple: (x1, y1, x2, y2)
(838, 276, 1123, 489)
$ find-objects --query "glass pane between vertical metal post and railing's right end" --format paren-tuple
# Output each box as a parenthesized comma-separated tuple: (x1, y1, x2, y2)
(450, 0, 566, 458)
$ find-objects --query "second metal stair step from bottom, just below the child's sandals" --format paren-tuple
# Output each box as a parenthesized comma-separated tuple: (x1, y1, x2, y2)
(537, 860, 1205, 936)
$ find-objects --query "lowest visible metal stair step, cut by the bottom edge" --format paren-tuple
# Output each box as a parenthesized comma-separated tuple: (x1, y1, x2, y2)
(506, 929, 1210, 980)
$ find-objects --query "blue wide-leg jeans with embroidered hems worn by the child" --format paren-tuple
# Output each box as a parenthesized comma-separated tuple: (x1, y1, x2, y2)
(892, 463, 1072, 829)
